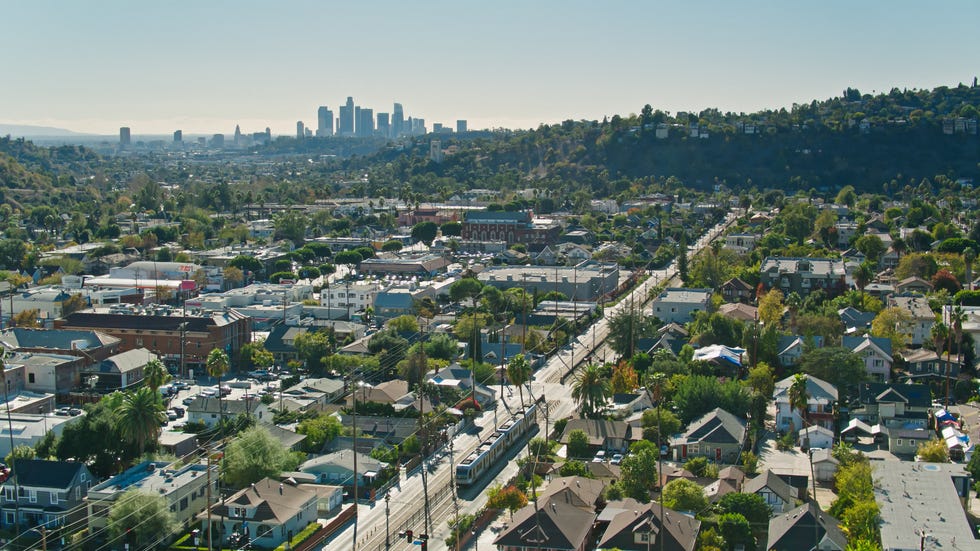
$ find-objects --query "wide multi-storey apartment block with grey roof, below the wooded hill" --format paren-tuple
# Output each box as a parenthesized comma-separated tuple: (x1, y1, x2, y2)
(759, 256, 846, 297)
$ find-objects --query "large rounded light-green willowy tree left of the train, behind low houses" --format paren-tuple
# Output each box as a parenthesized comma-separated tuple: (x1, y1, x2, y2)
(221, 425, 297, 488)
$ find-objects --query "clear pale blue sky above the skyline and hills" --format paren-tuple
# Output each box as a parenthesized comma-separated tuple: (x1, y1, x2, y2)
(0, 0, 980, 134)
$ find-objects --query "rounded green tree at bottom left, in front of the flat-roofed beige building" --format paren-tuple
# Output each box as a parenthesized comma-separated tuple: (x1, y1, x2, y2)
(108, 488, 179, 549)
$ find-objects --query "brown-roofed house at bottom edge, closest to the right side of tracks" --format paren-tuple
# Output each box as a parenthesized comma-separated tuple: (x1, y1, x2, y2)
(493, 496, 596, 551)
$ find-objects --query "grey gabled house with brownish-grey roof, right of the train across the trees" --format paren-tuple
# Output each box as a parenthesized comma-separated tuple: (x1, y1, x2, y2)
(670, 408, 746, 463)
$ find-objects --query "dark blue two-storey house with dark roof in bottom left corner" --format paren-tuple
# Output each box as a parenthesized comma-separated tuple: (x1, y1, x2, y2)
(0, 459, 95, 531)
